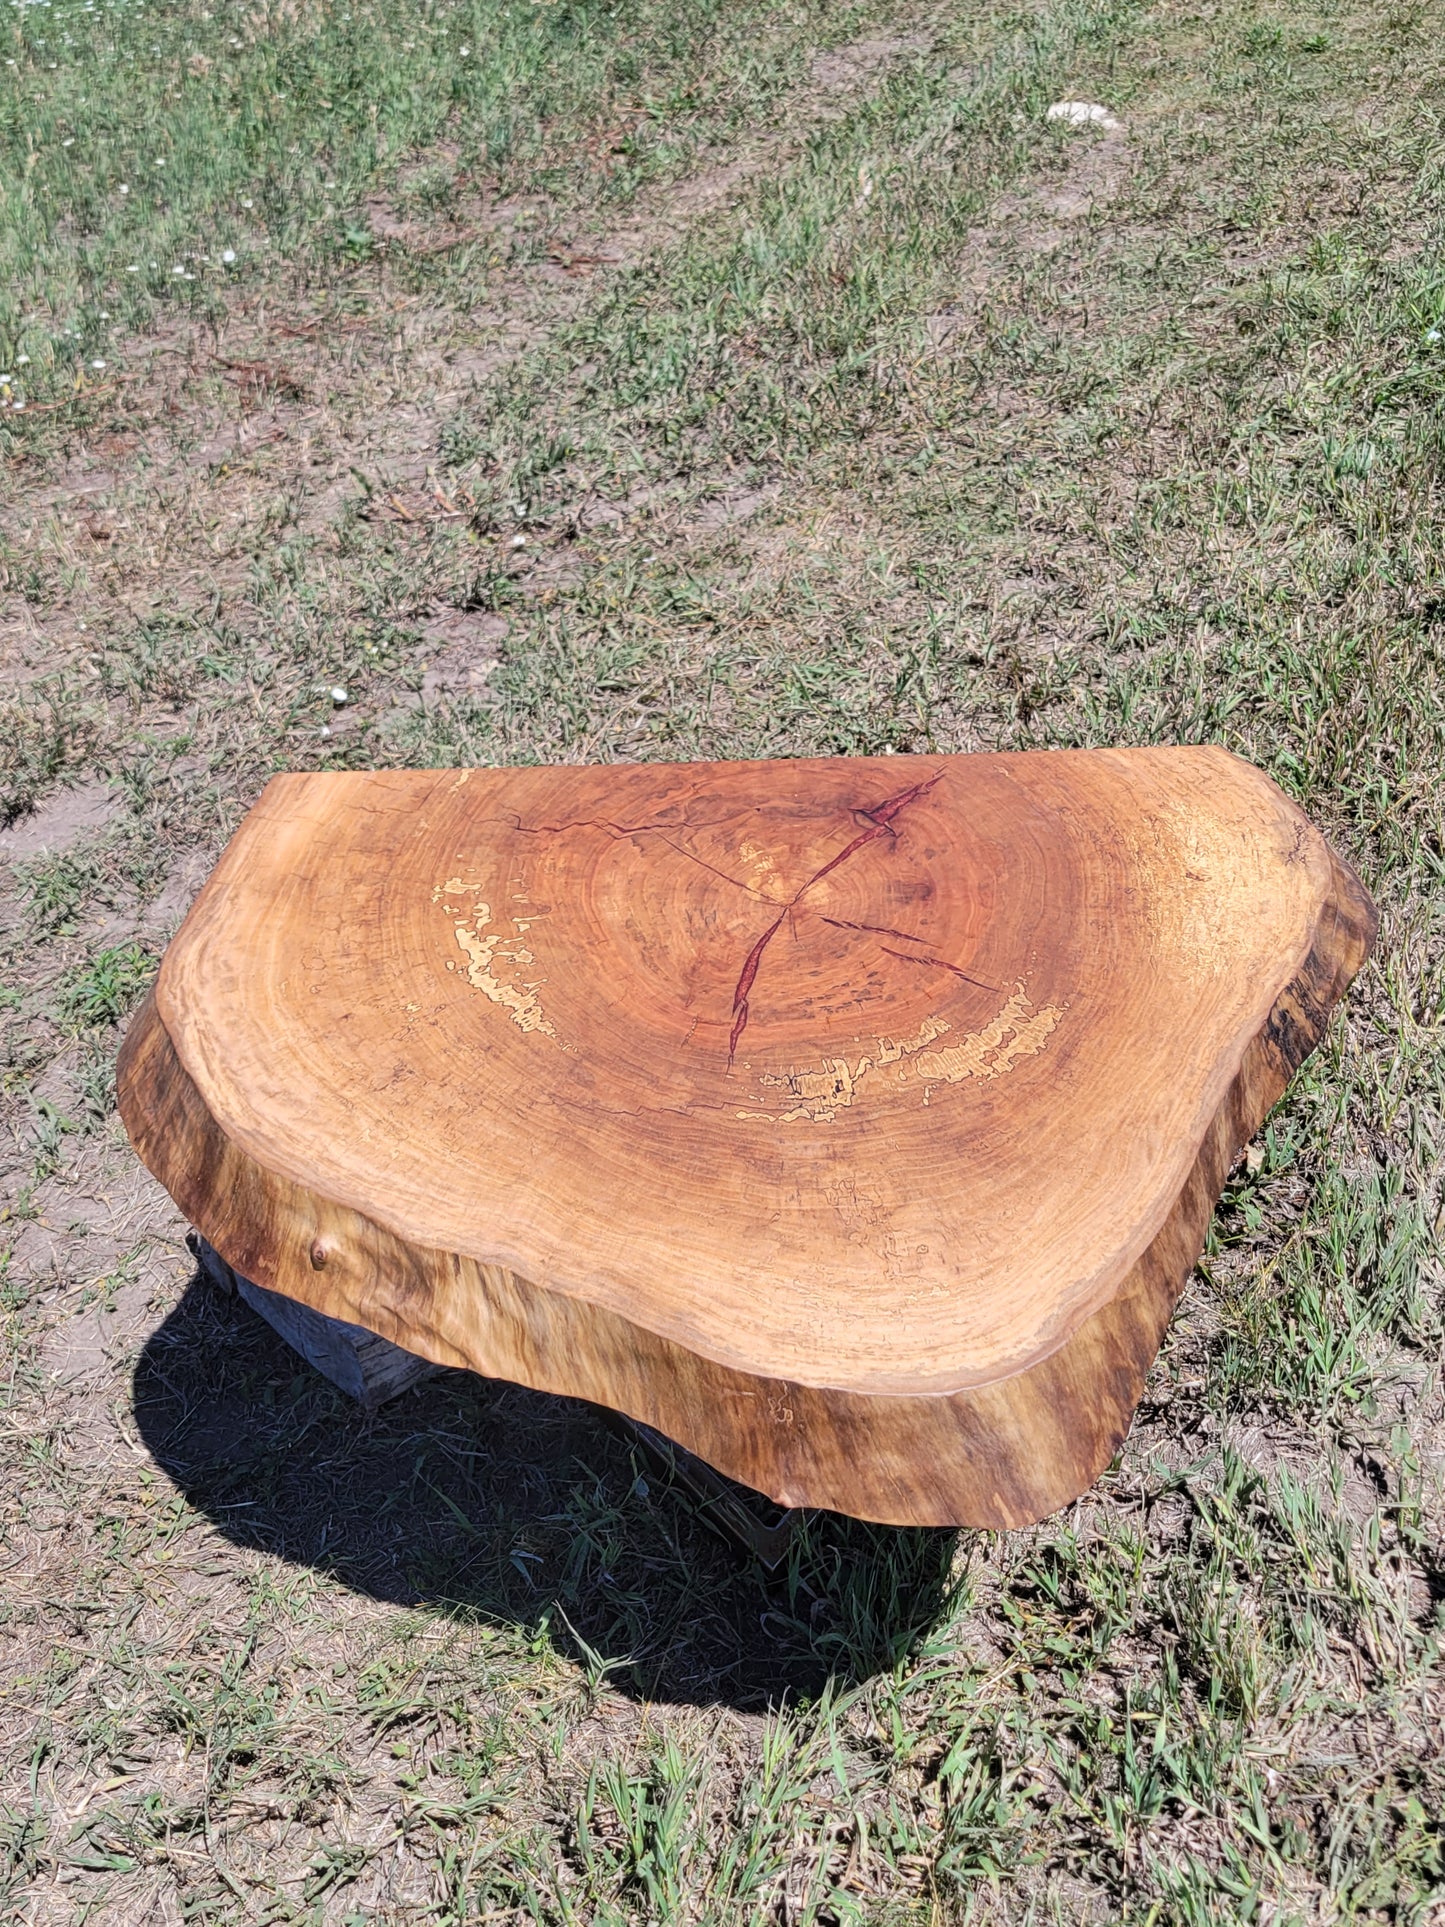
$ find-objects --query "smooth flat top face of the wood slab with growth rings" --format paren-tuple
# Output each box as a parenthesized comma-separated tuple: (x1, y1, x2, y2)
(141, 748, 1339, 1395)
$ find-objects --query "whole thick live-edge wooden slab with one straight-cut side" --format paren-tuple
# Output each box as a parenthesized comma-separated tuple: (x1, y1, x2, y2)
(119, 748, 1376, 1526)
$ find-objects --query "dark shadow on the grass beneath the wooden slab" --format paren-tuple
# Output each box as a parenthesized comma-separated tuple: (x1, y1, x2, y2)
(135, 1278, 958, 1709)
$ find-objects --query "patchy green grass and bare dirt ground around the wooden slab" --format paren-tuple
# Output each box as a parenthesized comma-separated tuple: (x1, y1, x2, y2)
(0, 0, 1445, 1927)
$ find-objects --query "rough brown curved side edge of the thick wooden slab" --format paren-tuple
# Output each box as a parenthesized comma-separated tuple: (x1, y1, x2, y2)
(118, 854, 1376, 1528)
